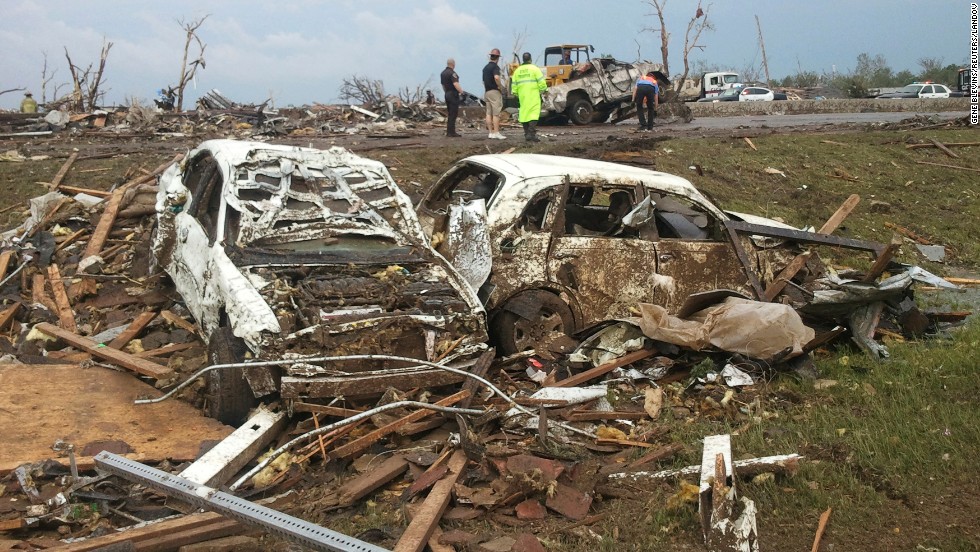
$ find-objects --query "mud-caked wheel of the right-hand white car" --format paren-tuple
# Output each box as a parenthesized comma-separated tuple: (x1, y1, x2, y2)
(490, 290, 575, 355)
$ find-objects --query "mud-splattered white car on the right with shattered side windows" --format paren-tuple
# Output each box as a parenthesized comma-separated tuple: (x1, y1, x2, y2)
(416, 154, 878, 353)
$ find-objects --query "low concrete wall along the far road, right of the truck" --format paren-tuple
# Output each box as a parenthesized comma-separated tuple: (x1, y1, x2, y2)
(686, 98, 970, 117)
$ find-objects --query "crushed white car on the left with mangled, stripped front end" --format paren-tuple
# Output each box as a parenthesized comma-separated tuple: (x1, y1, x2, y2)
(153, 140, 487, 423)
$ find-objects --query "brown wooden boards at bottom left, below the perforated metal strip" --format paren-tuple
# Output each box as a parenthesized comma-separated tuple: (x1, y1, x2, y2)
(58, 512, 247, 552)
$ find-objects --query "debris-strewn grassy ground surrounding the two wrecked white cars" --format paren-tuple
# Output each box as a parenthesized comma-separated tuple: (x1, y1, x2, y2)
(0, 110, 980, 552)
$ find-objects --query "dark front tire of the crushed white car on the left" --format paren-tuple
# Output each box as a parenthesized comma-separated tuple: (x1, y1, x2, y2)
(205, 327, 258, 426)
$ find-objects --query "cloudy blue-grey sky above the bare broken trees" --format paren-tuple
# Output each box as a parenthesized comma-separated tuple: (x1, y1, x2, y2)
(0, 0, 970, 108)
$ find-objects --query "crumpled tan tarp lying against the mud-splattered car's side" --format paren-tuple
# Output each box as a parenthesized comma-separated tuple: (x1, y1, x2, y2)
(640, 297, 814, 360)
